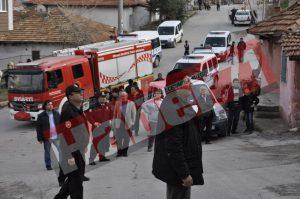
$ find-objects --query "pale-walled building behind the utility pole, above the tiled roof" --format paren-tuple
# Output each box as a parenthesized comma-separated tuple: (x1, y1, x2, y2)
(22, 0, 151, 31)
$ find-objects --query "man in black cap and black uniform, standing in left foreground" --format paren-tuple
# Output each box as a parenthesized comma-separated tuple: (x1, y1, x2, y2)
(54, 85, 89, 199)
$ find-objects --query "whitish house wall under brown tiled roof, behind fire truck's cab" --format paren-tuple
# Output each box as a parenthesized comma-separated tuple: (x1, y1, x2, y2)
(0, 43, 67, 70)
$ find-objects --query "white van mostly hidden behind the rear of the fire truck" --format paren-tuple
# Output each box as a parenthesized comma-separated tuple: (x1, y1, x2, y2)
(118, 30, 162, 67)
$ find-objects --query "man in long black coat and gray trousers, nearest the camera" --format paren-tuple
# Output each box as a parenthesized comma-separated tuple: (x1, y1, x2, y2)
(152, 69, 204, 199)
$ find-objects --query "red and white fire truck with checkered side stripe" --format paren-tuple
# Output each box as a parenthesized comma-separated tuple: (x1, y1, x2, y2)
(8, 41, 153, 121)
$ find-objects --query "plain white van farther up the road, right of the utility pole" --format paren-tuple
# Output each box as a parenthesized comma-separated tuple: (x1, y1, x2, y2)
(157, 21, 183, 48)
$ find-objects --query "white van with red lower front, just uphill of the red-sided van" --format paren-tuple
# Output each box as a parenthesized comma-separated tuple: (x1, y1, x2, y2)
(204, 31, 231, 62)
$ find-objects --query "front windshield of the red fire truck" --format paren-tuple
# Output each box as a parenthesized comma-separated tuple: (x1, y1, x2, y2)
(8, 71, 44, 93)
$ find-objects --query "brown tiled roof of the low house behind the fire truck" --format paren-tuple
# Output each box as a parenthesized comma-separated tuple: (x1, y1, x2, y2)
(0, 8, 113, 45)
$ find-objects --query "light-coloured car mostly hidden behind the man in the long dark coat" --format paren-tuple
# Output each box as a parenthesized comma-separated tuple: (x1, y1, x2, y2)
(145, 80, 228, 137)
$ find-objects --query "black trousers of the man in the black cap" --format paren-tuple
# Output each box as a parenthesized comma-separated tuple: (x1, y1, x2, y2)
(54, 152, 85, 199)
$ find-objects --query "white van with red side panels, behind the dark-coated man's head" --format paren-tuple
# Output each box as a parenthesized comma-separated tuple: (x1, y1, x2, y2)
(173, 54, 219, 87)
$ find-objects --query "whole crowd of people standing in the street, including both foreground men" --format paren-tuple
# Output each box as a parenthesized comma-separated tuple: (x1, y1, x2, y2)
(36, 65, 258, 199)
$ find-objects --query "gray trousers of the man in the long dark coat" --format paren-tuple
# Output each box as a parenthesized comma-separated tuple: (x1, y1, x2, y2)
(167, 184, 191, 199)
